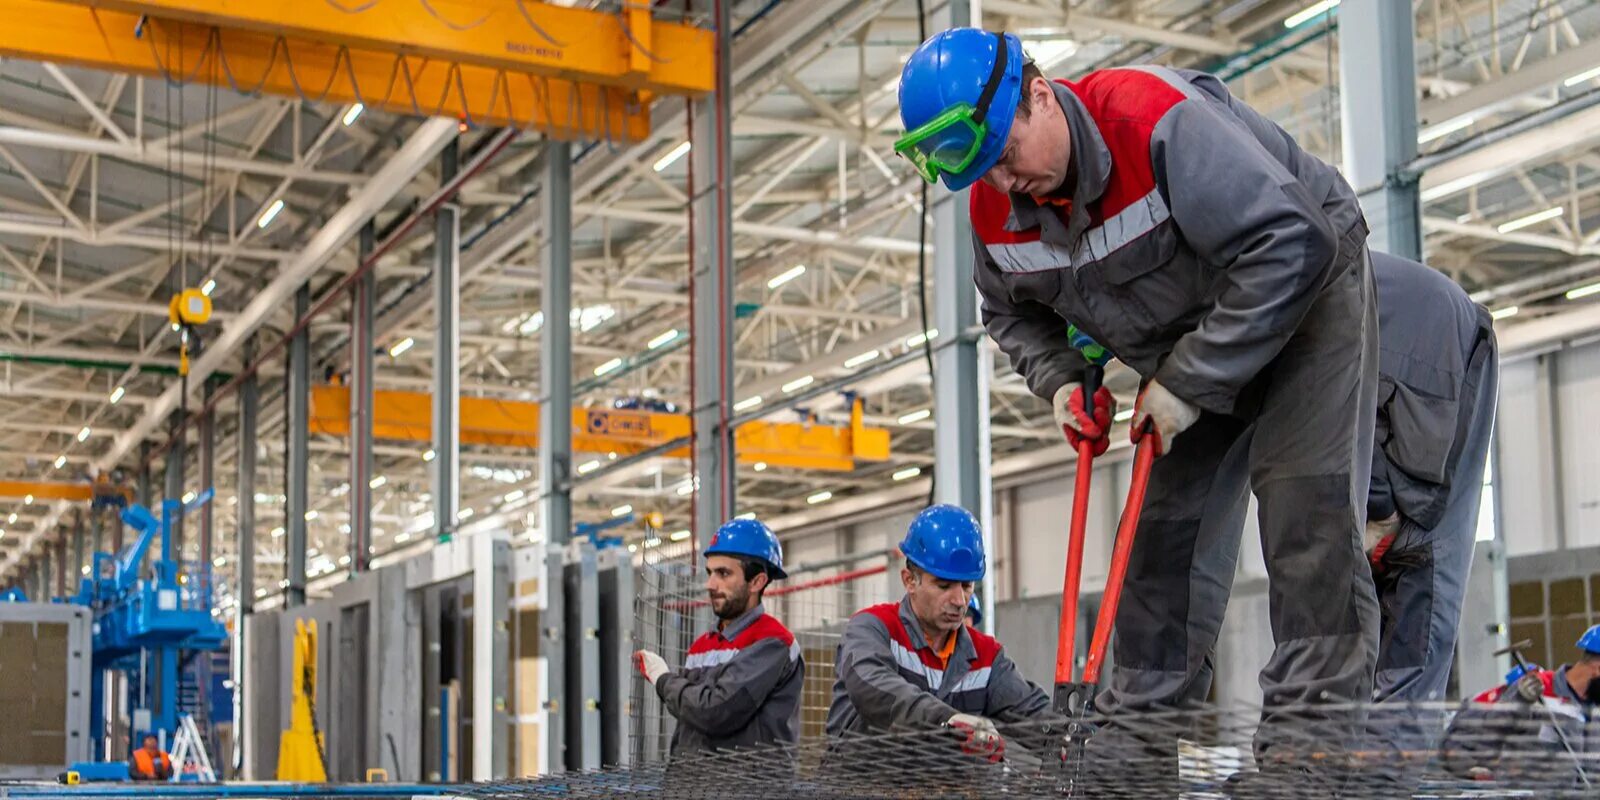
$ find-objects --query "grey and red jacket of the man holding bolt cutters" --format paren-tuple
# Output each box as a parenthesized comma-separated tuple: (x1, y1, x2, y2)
(970, 66, 1366, 416)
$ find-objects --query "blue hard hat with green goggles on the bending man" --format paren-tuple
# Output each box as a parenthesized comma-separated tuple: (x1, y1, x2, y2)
(896, 27, 1027, 192)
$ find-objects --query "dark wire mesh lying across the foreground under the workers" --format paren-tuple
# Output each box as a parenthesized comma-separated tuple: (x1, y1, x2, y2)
(461, 702, 1600, 800)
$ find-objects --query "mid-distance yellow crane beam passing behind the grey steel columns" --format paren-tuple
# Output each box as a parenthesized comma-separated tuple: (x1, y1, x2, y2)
(309, 386, 890, 472)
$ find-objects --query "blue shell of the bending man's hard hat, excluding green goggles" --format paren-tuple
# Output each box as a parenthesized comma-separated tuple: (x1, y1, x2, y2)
(899, 27, 1027, 192)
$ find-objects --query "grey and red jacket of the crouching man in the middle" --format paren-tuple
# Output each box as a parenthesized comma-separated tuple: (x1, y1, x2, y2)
(827, 597, 1050, 738)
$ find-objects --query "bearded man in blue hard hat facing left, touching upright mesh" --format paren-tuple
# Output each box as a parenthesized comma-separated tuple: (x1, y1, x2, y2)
(634, 520, 805, 755)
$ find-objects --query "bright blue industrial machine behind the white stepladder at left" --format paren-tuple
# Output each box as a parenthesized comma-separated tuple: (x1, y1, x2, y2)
(66, 490, 227, 779)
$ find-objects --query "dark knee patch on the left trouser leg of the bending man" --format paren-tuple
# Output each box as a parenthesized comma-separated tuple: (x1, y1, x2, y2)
(1115, 520, 1198, 672)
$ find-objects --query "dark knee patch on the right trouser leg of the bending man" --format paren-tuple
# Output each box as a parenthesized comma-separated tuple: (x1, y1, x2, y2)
(1256, 474, 1370, 642)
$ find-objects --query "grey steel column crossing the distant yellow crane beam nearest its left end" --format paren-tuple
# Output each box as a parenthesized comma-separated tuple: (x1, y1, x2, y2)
(350, 222, 378, 573)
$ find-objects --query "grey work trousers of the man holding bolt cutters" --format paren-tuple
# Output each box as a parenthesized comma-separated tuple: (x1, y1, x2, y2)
(1091, 246, 1379, 766)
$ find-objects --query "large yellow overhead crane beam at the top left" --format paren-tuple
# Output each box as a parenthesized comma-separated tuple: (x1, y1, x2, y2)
(0, 0, 714, 142)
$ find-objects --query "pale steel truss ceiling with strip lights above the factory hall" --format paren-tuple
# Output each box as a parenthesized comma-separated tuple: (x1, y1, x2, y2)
(0, 0, 1600, 597)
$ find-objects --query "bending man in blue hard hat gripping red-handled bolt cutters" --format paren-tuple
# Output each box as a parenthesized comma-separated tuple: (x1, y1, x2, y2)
(896, 29, 1378, 797)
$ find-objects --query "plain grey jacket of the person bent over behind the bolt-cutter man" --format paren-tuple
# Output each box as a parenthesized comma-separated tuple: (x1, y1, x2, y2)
(1366, 253, 1498, 530)
